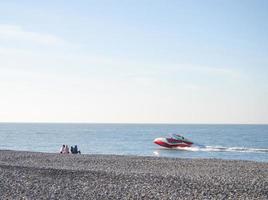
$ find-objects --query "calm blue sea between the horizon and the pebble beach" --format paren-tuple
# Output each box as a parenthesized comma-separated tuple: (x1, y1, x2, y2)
(0, 123, 268, 162)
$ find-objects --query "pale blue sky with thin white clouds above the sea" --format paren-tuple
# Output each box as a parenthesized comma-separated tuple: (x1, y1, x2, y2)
(0, 0, 268, 124)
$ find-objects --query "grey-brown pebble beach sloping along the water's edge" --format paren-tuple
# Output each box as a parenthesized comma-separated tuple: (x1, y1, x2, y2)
(0, 150, 268, 200)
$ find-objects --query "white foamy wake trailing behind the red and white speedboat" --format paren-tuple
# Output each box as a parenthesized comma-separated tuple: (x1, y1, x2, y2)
(177, 146, 268, 153)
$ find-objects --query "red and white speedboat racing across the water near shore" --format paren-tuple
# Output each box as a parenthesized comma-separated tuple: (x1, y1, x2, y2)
(154, 134, 193, 148)
